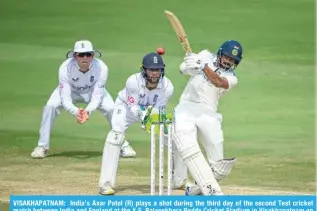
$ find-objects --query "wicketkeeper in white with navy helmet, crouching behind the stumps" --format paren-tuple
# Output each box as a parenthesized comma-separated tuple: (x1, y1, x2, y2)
(99, 53, 178, 195)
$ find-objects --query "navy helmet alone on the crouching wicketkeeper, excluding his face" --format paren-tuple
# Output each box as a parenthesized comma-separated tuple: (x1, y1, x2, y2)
(141, 53, 165, 79)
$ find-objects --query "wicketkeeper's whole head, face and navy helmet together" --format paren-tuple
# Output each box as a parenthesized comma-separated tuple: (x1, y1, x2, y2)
(141, 53, 165, 83)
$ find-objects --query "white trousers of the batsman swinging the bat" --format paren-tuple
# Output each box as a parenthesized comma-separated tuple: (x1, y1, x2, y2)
(174, 102, 224, 166)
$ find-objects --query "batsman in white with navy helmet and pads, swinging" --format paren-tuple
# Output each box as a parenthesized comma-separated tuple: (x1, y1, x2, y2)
(174, 40, 242, 195)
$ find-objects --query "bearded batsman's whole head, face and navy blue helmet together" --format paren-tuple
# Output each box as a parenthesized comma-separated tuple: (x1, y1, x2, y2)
(217, 40, 242, 69)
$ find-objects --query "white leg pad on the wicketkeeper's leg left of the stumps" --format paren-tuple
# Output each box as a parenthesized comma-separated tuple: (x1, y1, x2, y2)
(99, 131, 124, 188)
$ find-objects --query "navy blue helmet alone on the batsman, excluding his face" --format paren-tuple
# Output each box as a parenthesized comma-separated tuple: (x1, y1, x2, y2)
(217, 40, 242, 66)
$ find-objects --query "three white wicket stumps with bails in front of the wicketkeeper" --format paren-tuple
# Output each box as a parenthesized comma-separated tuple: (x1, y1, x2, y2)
(151, 121, 173, 195)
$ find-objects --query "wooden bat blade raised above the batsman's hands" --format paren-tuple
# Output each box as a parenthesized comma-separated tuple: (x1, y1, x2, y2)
(165, 10, 192, 53)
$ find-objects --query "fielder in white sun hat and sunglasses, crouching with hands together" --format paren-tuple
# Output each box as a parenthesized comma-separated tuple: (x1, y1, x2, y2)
(31, 40, 135, 158)
